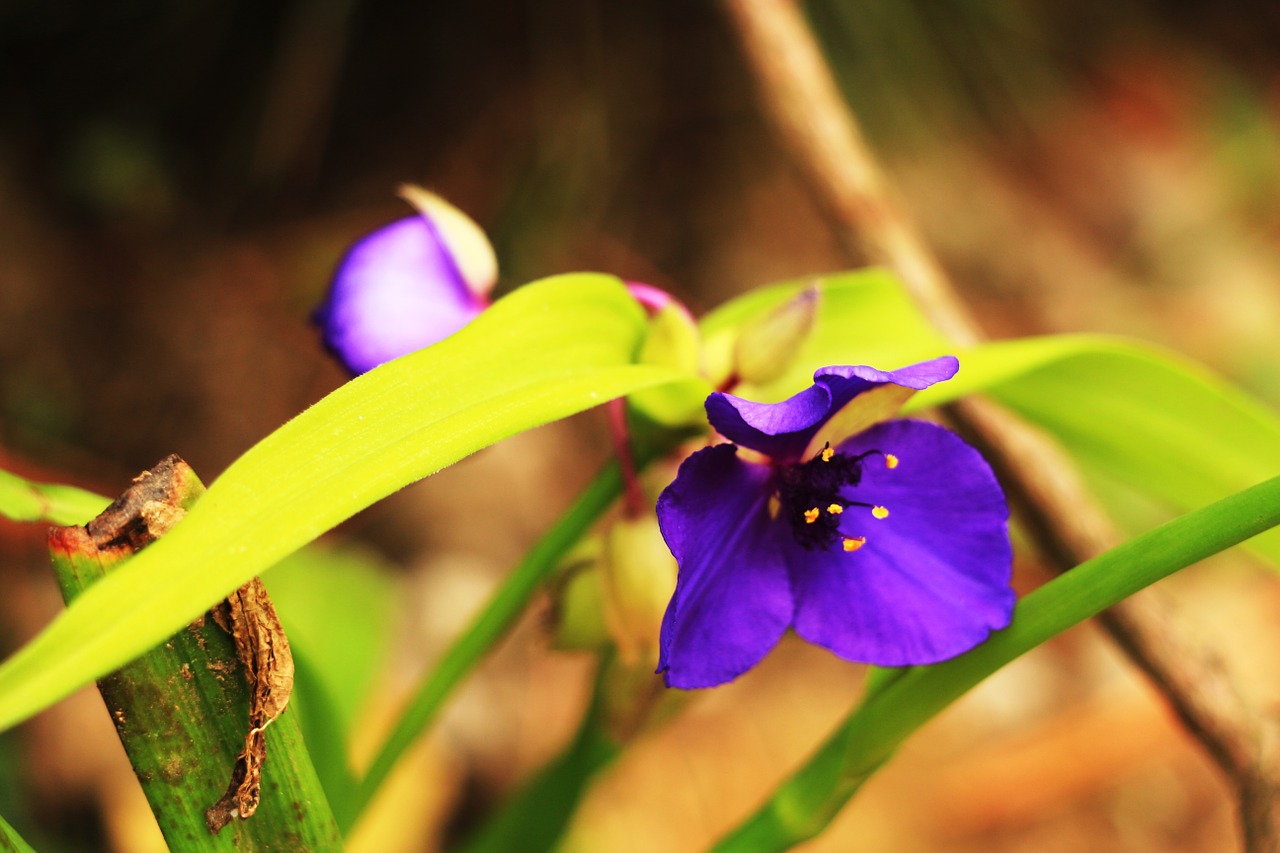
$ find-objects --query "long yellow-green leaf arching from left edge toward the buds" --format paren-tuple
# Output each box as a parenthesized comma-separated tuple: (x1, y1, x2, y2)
(0, 274, 681, 730)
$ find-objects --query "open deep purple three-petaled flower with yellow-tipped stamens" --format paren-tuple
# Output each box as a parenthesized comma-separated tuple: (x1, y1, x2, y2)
(658, 356, 1014, 688)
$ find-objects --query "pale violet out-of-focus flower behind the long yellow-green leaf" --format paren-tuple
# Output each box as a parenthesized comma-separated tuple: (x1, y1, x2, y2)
(315, 187, 497, 374)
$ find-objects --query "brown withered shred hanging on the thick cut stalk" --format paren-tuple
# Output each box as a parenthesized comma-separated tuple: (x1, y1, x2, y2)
(205, 578, 293, 835)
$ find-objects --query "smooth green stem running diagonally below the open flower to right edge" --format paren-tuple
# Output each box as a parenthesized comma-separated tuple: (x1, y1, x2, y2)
(714, 478, 1280, 853)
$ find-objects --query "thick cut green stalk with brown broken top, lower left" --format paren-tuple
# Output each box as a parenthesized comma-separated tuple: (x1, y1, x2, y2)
(50, 457, 342, 850)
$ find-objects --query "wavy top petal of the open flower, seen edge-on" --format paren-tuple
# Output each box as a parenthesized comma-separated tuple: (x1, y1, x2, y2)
(707, 356, 960, 461)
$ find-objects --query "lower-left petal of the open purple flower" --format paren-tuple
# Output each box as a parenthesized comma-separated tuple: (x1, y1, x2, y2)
(658, 444, 792, 688)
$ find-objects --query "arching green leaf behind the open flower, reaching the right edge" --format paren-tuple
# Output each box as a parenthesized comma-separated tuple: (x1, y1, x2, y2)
(911, 336, 1280, 567)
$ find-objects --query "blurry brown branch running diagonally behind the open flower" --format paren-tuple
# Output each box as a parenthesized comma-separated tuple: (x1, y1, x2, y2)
(722, 0, 1280, 853)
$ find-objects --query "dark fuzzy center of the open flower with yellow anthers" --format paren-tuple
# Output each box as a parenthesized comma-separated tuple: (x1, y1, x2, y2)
(774, 444, 897, 551)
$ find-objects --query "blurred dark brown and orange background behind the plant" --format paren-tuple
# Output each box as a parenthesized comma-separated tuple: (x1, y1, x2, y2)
(0, 0, 1280, 852)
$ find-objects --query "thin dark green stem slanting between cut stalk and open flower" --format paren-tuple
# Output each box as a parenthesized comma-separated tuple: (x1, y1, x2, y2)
(342, 464, 622, 834)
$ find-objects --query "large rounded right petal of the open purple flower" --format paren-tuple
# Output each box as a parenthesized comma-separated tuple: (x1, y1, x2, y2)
(787, 420, 1014, 666)
